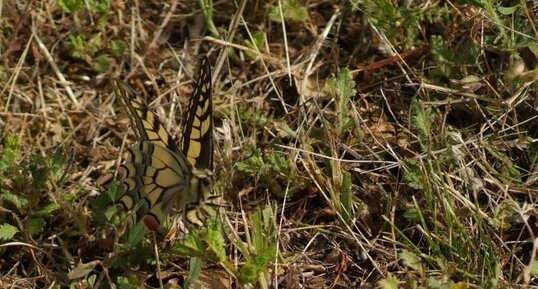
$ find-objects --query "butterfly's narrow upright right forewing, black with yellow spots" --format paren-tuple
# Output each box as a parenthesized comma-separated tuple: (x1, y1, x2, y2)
(181, 57, 213, 170)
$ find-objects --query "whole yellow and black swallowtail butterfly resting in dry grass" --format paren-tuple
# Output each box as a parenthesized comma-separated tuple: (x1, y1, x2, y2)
(115, 57, 218, 231)
